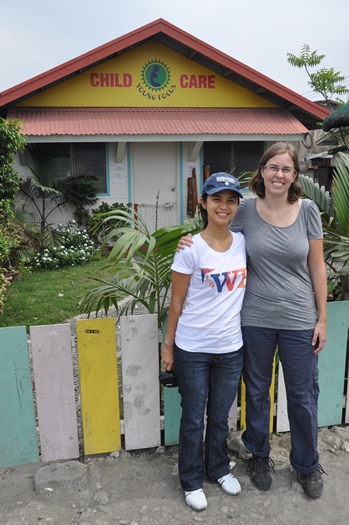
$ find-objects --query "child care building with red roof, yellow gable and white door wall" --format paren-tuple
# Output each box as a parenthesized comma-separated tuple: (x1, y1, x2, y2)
(0, 19, 329, 230)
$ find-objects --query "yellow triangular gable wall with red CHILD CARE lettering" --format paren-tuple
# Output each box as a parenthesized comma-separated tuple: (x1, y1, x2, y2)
(19, 42, 275, 108)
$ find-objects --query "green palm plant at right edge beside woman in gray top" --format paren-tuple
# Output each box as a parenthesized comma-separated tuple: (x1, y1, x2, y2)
(299, 152, 349, 300)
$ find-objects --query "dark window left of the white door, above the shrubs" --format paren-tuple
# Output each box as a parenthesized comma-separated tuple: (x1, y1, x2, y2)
(35, 142, 107, 194)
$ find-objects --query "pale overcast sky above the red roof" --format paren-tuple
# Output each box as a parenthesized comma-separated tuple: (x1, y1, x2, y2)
(0, 0, 349, 100)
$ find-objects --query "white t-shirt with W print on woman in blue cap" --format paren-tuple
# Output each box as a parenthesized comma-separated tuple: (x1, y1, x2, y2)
(172, 233, 246, 354)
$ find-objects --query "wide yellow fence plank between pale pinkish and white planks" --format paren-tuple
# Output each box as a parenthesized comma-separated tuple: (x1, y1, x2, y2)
(76, 318, 121, 455)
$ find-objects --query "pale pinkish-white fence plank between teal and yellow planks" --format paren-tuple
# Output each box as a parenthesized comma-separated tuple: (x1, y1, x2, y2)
(30, 323, 79, 461)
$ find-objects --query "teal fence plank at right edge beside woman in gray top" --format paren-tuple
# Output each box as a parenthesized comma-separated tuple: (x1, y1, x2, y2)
(318, 301, 349, 427)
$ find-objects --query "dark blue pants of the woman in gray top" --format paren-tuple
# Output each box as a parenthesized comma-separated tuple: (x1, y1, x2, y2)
(242, 326, 319, 474)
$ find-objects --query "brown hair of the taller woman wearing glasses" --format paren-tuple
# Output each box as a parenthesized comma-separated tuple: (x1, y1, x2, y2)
(249, 142, 302, 203)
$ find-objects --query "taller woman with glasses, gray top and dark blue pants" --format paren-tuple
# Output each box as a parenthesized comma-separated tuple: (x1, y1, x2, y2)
(181, 142, 327, 498)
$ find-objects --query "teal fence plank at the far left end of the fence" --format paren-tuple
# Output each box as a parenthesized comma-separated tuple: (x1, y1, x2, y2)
(0, 326, 39, 467)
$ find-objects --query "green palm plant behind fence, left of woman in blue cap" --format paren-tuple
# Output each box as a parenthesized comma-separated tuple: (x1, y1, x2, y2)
(80, 199, 202, 328)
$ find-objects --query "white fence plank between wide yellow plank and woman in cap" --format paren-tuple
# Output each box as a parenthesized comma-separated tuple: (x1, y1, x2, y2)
(120, 314, 161, 450)
